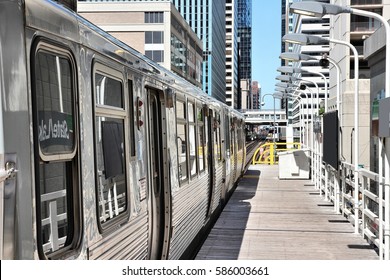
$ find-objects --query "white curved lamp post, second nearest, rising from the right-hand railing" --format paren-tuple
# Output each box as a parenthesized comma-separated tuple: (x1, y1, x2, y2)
(283, 32, 359, 234)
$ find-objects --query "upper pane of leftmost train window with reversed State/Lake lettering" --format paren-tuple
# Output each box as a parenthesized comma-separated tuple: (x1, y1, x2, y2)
(35, 51, 75, 157)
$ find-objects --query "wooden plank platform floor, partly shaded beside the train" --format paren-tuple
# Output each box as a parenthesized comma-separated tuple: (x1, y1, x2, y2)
(196, 165, 379, 260)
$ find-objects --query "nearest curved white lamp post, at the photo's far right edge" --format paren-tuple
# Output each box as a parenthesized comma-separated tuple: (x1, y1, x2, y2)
(290, 1, 390, 260)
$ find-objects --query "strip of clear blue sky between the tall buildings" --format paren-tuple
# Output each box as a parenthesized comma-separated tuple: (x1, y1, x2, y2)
(252, 0, 282, 109)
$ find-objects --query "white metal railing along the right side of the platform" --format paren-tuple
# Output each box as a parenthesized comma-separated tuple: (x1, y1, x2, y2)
(319, 159, 390, 260)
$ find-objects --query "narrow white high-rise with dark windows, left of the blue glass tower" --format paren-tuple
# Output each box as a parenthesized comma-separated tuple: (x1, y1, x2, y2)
(226, 0, 239, 109)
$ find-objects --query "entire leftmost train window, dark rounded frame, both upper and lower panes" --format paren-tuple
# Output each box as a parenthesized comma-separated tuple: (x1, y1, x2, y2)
(32, 41, 81, 259)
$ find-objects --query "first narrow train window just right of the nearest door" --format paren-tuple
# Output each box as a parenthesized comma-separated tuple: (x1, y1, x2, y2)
(176, 100, 188, 182)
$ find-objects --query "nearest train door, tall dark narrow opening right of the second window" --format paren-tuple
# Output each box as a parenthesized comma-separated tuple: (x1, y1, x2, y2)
(147, 88, 170, 259)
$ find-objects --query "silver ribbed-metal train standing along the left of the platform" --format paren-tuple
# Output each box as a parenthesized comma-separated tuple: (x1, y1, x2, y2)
(0, 0, 245, 260)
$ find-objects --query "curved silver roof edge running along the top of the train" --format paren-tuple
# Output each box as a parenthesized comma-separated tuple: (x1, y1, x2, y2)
(25, 0, 243, 118)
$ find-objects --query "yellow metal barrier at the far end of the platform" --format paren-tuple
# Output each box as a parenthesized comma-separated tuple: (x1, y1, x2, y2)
(252, 142, 301, 165)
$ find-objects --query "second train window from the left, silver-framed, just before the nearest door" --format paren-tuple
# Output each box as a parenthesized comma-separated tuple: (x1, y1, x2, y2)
(94, 64, 128, 230)
